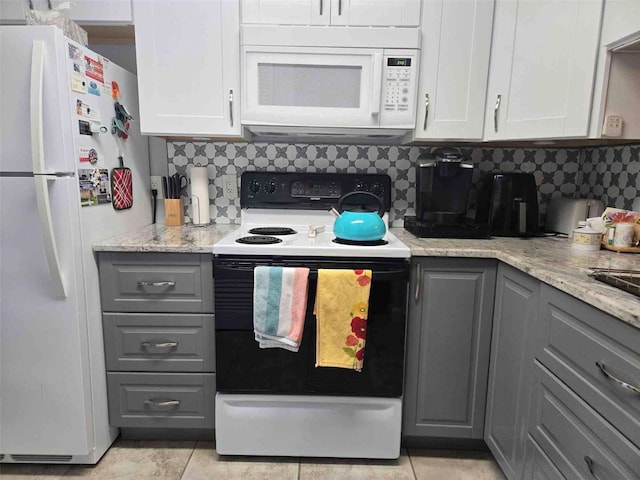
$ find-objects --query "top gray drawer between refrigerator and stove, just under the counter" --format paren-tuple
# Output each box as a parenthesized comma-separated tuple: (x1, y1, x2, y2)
(100, 253, 213, 313)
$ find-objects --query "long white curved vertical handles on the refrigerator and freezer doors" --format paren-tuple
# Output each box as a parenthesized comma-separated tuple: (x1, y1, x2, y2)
(30, 41, 67, 298)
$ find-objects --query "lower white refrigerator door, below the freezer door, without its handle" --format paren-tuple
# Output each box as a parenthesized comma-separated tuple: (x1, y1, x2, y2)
(0, 177, 93, 456)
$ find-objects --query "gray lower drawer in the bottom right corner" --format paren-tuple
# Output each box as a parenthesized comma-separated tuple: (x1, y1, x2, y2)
(529, 361, 640, 480)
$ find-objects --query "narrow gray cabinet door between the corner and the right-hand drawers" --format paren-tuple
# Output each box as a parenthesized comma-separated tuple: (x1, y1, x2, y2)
(484, 263, 540, 480)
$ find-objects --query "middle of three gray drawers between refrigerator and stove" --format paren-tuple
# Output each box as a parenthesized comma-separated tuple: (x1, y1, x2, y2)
(102, 313, 215, 372)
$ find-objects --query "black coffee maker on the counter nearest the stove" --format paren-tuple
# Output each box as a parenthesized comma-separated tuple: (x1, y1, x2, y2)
(404, 147, 489, 238)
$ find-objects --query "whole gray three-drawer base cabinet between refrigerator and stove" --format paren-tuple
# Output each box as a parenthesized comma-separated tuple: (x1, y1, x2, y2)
(99, 252, 216, 431)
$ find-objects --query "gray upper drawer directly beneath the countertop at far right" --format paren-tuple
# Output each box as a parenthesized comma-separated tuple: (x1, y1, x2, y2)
(536, 286, 640, 447)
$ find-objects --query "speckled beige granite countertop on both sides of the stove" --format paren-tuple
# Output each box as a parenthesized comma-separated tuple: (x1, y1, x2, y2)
(93, 224, 640, 328)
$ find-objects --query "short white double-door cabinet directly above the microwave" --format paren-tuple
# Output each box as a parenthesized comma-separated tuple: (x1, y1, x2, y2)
(241, 0, 421, 27)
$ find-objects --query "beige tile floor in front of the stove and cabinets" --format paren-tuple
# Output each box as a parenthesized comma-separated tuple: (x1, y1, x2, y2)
(0, 440, 504, 480)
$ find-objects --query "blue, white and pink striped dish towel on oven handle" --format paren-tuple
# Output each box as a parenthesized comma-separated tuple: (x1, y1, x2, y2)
(253, 267, 309, 352)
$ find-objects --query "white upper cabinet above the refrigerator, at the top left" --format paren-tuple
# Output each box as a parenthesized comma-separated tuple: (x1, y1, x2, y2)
(0, 0, 133, 25)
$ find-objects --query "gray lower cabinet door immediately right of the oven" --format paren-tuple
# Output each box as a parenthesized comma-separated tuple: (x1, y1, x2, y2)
(403, 257, 497, 439)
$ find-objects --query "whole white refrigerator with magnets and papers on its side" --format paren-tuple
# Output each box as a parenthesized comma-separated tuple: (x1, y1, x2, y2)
(0, 26, 151, 464)
